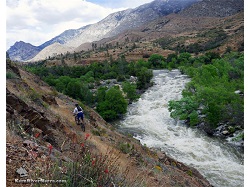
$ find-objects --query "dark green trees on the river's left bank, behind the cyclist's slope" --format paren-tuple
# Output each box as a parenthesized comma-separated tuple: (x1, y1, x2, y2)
(25, 56, 156, 120)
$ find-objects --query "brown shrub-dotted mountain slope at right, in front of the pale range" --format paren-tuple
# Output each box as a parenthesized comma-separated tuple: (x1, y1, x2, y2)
(66, 0, 244, 64)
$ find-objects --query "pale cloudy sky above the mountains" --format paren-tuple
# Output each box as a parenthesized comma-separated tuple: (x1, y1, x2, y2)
(6, 0, 153, 50)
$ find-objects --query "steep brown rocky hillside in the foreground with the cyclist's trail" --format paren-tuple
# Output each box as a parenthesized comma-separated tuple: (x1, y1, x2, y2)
(6, 60, 211, 187)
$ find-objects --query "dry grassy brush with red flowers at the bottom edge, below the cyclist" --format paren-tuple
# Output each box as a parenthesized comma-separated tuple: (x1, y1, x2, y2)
(48, 147, 131, 187)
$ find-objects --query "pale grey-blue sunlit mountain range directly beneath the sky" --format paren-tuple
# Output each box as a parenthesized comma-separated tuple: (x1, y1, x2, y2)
(7, 0, 199, 61)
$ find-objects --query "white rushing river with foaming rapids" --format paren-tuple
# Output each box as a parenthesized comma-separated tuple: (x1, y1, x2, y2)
(116, 70, 244, 187)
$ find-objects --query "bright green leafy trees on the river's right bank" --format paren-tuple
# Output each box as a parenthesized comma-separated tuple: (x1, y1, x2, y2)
(169, 53, 244, 128)
